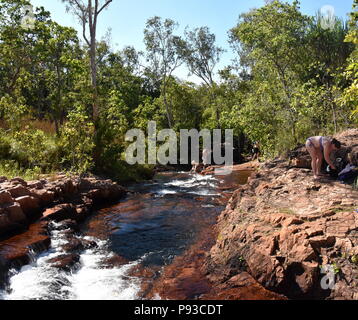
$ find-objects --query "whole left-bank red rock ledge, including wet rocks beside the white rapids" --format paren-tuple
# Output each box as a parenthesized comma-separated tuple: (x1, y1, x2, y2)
(0, 175, 126, 288)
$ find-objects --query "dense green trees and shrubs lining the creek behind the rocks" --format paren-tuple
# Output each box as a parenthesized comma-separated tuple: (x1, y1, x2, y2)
(0, 0, 358, 181)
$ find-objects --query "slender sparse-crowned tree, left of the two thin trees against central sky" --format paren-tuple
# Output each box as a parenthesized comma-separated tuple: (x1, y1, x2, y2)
(144, 16, 184, 128)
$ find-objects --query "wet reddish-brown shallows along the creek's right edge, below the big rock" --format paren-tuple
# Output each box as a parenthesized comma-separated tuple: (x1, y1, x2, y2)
(141, 164, 285, 300)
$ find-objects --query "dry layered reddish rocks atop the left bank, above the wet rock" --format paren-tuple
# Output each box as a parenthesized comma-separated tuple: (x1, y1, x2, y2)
(0, 175, 126, 238)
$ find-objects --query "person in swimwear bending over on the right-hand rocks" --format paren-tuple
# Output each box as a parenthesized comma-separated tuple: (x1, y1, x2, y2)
(306, 136, 341, 179)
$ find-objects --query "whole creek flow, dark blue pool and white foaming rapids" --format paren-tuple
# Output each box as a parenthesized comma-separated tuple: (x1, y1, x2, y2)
(0, 173, 232, 300)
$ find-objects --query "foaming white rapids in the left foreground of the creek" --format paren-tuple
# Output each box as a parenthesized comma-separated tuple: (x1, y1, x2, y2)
(0, 224, 140, 300)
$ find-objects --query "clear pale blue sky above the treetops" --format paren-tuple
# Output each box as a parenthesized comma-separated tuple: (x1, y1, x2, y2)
(31, 0, 353, 82)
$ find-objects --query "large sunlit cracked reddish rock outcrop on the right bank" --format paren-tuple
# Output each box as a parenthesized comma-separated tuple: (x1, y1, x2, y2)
(203, 130, 358, 299)
